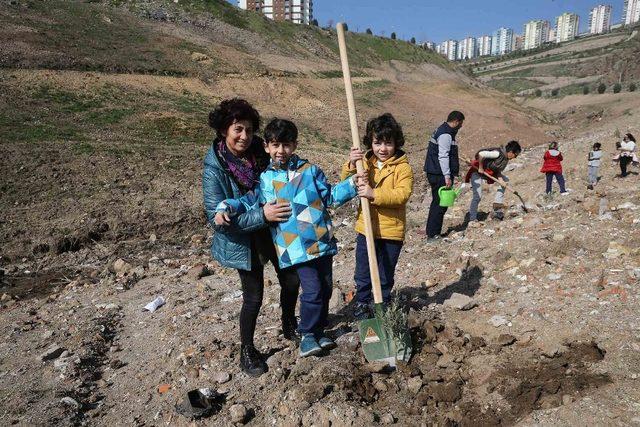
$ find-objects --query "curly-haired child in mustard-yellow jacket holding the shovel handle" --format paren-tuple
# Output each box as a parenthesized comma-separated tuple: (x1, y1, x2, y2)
(341, 113, 413, 320)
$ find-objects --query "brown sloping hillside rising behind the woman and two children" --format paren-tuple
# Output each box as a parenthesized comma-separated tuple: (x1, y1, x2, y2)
(0, 0, 544, 257)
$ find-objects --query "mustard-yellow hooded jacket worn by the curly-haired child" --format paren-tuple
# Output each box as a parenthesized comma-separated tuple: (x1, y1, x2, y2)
(340, 150, 413, 241)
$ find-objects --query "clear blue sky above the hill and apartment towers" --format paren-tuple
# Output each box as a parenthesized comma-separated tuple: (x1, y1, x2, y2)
(270, 0, 624, 43)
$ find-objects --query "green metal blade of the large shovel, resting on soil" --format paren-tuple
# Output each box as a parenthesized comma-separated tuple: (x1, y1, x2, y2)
(358, 304, 412, 366)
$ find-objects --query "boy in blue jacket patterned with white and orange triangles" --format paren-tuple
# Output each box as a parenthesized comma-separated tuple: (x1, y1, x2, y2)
(216, 119, 360, 357)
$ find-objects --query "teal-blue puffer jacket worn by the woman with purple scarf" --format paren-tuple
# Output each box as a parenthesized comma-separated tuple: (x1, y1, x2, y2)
(202, 138, 268, 271)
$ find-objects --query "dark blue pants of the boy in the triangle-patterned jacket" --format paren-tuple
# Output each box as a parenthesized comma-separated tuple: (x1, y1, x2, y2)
(293, 256, 333, 334)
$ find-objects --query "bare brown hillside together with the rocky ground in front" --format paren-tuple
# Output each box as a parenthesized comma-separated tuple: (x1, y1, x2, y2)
(6, 0, 640, 426)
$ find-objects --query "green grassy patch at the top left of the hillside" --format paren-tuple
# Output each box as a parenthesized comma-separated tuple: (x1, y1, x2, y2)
(10, 0, 205, 76)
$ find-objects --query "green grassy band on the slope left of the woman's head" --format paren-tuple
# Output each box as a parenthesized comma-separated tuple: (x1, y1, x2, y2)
(0, 79, 216, 147)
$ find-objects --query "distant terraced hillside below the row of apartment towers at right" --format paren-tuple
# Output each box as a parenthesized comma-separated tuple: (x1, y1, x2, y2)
(468, 27, 640, 134)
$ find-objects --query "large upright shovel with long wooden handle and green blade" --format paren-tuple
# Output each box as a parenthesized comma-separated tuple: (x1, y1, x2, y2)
(337, 23, 411, 366)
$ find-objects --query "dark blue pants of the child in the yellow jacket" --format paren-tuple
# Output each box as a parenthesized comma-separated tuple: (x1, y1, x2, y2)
(354, 233, 402, 304)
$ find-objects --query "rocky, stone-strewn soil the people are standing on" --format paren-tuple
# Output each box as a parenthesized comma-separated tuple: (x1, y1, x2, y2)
(0, 122, 640, 425)
